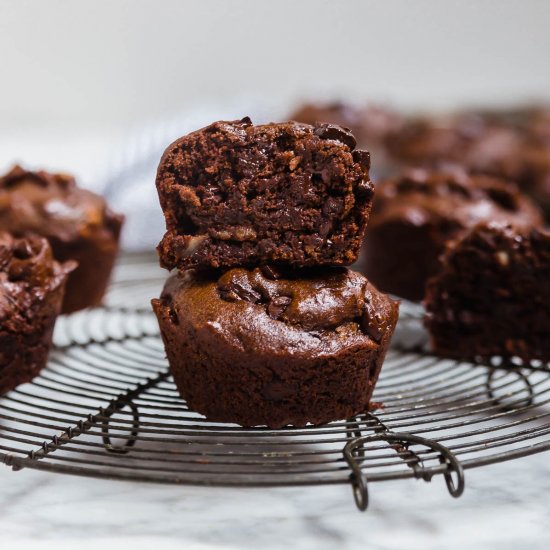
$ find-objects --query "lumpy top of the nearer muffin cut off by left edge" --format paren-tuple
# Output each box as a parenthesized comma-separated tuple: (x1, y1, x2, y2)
(0, 231, 76, 331)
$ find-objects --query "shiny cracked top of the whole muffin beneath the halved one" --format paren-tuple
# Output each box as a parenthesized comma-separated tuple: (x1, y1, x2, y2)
(157, 267, 397, 355)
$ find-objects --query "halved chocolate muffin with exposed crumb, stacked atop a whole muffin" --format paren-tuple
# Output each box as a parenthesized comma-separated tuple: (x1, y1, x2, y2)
(156, 118, 373, 269)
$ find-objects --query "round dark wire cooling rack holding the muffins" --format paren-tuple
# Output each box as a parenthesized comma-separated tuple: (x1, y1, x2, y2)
(0, 257, 550, 510)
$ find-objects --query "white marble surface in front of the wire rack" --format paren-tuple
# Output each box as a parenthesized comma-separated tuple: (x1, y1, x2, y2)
(0, 454, 550, 550)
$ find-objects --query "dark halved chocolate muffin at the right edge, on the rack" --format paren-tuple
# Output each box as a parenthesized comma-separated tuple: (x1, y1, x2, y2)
(425, 223, 550, 362)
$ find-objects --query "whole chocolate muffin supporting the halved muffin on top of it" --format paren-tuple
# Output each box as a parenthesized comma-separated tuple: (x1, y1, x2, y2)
(152, 267, 398, 428)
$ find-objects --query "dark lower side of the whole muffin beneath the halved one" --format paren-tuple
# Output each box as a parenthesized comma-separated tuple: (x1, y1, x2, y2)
(152, 268, 397, 428)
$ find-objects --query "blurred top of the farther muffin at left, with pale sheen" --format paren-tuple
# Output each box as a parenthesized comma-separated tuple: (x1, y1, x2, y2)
(0, 166, 121, 241)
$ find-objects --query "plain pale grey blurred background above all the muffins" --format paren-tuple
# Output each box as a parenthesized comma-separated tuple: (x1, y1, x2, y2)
(0, 0, 550, 132)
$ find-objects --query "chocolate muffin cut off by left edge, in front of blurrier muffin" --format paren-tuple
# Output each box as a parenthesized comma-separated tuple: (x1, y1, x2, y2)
(0, 231, 75, 394)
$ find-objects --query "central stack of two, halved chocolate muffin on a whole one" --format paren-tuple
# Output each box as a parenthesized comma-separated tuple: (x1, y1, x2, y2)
(152, 118, 397, 428)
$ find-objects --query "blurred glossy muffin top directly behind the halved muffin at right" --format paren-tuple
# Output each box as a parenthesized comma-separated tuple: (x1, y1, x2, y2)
(370, 166, 543, 231)
